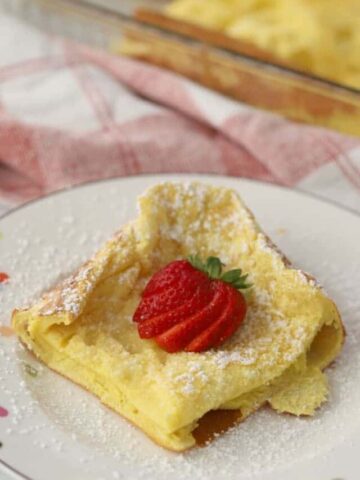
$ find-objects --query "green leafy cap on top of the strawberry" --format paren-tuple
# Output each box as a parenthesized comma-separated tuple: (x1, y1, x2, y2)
(187, 255, 252, 290)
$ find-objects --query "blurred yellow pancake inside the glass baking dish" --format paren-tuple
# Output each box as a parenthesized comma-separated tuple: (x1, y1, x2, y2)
(166, 0, 360, 89)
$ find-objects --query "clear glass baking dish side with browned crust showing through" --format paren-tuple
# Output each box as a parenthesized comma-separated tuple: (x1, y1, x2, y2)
(4, 0, 360, 136)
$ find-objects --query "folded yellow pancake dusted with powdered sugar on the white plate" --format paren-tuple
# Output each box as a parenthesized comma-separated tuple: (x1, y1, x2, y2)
(13, 183, 344, 451)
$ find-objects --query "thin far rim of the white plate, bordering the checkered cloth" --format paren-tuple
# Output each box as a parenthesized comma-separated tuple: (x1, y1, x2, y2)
(0, 172, 360, 221)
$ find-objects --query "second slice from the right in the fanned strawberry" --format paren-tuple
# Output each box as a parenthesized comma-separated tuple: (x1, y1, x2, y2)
(155, 284, 227, 352)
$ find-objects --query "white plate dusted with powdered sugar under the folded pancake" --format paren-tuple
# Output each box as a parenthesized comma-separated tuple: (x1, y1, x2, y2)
(0, 175, 360, 480)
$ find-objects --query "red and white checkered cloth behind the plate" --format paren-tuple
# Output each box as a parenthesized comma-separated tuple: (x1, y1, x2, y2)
(0, 16, 360, 217)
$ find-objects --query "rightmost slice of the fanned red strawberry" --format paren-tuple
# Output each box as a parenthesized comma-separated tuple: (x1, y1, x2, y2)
(184, 286, 238, 352)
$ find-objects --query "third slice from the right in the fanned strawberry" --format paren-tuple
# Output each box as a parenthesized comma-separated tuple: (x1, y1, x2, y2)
(138, 284, 215, 338)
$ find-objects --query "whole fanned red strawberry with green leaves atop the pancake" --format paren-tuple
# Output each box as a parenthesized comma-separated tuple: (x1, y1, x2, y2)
(133, 256, 250, 353)
